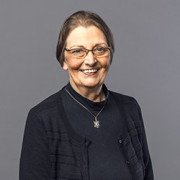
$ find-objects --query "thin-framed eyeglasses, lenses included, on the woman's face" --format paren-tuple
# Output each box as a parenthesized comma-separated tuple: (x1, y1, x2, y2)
(65, 45, 111, 59)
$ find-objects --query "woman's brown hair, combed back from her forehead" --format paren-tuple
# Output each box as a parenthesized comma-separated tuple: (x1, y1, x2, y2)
(56, 11, 114, 66)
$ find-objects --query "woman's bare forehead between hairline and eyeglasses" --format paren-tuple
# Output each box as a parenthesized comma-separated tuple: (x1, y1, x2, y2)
(66, 26, 107, 47)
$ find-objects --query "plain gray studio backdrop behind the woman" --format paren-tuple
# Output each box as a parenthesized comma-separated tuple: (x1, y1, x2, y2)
(0, 0, 180, 180)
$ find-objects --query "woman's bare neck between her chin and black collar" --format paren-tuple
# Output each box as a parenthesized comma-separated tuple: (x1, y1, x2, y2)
(70, 82, 105, 102)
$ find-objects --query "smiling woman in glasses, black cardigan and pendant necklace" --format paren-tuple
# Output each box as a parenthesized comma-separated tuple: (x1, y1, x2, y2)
(20, 11, 153, 180)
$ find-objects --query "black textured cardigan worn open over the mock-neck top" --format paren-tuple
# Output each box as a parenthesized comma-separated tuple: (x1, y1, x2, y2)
(19, 90, 154, 180)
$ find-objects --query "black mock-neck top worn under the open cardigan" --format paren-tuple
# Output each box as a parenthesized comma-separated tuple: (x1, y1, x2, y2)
(62, 84, 132, 180)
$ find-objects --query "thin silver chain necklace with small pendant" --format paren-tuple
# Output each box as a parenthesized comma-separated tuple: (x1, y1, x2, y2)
(65, 88, 107, 128)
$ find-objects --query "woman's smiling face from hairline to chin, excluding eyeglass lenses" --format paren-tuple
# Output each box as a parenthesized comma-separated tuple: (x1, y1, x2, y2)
(63, 26, 110, 93)
